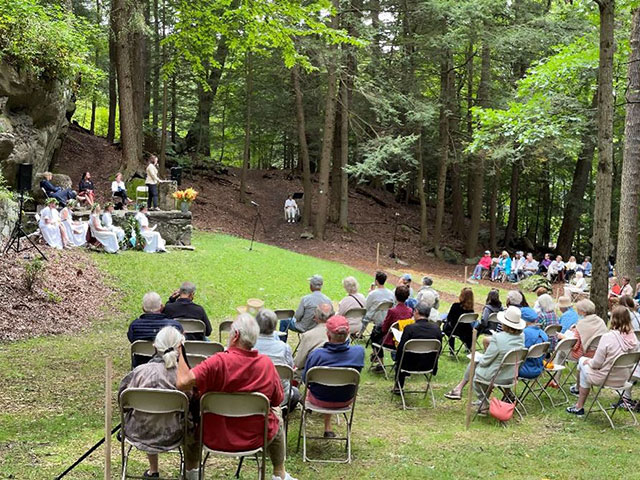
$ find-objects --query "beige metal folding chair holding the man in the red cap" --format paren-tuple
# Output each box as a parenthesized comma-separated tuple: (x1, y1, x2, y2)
(298, 367, 360, 463)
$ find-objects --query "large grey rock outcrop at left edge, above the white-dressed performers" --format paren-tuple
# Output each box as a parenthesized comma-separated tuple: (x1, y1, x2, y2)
(0, 63, 75, 190)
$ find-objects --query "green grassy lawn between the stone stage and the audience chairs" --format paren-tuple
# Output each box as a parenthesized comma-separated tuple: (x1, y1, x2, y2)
(0, 233, 640, 479)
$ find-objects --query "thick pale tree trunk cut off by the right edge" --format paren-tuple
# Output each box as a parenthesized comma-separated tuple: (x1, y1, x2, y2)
(616, 9, 640, 288)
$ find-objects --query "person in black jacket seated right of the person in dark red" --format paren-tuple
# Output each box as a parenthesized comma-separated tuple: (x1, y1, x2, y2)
(393, 303, 442, 393)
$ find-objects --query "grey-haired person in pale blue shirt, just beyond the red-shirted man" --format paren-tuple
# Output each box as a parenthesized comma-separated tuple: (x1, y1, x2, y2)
(254, 309, 300, 413)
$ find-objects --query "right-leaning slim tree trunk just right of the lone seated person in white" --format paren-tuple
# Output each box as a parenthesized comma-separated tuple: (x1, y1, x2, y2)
(314, 0, 340, 240)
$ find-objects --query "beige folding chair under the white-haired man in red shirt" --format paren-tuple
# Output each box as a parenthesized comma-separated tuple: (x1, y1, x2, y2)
(200, 392, 271, 480)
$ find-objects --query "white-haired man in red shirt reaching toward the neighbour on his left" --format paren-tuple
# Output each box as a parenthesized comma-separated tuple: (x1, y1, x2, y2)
(176, 313, 295, 480)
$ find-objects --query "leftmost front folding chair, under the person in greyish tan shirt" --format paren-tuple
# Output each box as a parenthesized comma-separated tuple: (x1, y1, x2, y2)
(120, 388, 189, 480)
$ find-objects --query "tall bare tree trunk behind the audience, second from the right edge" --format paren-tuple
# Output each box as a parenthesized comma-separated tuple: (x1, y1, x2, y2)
(591, 0, 615, 318)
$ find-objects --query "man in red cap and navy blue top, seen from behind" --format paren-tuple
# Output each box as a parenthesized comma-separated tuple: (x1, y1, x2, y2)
(302, 315, 364, 438)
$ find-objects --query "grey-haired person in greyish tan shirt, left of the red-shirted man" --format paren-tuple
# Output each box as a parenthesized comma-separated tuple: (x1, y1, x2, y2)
(118, 327, 199, 480)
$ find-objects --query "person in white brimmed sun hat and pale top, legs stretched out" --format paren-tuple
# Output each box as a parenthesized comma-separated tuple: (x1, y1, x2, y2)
(445, 307, 526, 408)
